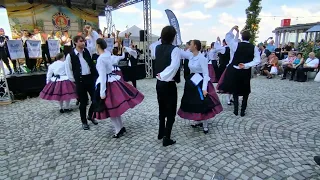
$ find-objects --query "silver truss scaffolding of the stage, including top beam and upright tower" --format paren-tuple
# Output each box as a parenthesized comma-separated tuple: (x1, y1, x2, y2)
(105, 0, 153, 78)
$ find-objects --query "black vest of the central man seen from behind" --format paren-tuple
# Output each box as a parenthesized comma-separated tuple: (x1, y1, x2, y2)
(154, 44, 180, 83)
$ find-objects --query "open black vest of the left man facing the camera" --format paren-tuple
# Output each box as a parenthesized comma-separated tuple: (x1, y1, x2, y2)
(70, 48, 98, 83)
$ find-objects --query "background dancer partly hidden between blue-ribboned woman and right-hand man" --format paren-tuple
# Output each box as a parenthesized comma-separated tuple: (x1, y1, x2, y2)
(207, 43, 218, 83)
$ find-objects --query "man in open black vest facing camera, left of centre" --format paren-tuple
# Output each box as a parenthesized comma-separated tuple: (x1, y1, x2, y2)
(66, 36, 98, 130)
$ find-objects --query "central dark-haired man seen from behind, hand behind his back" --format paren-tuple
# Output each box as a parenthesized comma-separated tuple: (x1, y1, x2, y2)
(155, 26, 181, 146)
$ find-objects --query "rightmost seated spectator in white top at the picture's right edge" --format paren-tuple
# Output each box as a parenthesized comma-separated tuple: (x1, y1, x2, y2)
(297, 52, 319, 82)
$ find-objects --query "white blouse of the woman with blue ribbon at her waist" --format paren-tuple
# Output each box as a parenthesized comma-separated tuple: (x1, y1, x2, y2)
(189, 52, 210, 91)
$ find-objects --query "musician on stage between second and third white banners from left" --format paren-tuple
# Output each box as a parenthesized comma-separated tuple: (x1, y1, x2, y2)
(33, 28, 51, 69)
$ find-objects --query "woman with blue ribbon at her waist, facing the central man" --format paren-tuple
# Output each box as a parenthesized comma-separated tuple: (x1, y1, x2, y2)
(178, 40, 222, 134)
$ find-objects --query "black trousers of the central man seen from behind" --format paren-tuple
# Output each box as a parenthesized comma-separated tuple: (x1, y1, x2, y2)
(156, 80, 178, 139)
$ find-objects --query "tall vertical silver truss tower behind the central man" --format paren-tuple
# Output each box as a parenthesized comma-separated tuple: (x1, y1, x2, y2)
(143, 0, 153, 78)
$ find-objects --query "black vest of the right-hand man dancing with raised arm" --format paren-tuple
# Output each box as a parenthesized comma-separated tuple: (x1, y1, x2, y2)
(231, 42, 255, 66)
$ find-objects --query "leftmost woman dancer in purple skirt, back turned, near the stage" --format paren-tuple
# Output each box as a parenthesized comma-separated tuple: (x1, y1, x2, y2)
(40, 53, 77, 113)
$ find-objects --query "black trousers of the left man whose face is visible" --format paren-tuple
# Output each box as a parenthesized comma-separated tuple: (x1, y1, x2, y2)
(76, 75, 95, 124)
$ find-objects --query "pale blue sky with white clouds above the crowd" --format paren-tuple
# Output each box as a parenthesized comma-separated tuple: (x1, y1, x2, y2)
(100, 0, 320, 44)
